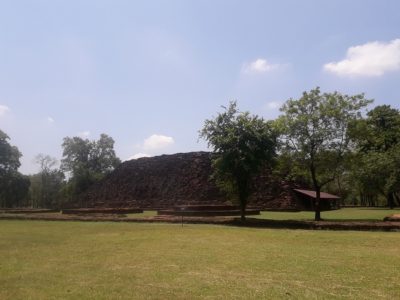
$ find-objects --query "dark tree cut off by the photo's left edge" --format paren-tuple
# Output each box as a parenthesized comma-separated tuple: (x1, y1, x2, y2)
(0, 130, 29, 207)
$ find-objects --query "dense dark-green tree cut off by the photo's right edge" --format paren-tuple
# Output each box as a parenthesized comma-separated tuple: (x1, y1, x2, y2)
(350, 105, 400, 208)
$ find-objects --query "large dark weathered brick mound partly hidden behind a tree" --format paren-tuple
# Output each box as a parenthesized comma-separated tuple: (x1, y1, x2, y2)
(83, 152, 296, 209)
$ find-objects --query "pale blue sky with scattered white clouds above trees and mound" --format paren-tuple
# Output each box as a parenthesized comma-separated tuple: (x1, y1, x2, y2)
(0, 0, 400, 174)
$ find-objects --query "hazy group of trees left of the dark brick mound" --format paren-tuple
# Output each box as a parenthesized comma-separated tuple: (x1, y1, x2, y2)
(0, 131, 120, 209)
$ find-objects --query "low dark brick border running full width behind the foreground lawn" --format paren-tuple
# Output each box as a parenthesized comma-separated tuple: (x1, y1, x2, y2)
(0, 214, 400, 231)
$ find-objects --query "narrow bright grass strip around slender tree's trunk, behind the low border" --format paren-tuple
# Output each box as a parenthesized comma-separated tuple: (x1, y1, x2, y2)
(254, 207, 400, 221)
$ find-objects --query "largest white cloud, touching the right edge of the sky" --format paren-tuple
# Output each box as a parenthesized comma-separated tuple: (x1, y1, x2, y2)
(324, 39, 400, 77)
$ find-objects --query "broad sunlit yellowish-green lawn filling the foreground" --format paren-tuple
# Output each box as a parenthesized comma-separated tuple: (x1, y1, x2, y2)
(0, 220, 400, 299)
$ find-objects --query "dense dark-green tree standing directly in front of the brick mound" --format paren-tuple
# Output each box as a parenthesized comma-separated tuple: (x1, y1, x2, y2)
(200, 102, 276, 221)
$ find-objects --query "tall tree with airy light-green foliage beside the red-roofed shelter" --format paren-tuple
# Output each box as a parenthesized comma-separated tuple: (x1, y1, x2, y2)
(276, 87, 372, 220)
